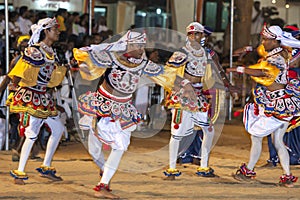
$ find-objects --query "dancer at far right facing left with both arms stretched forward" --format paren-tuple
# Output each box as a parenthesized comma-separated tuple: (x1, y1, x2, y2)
(227, 25, 300, 187)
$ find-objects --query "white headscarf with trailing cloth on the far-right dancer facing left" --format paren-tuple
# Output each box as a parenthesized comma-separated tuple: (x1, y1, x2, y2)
(261, 24, 300, 48)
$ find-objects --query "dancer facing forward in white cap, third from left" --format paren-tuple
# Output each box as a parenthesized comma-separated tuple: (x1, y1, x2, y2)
(164, 22, 236, 180)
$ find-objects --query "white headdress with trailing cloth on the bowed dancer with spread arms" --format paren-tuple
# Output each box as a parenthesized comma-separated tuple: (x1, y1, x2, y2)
(91, 31, 147, 52)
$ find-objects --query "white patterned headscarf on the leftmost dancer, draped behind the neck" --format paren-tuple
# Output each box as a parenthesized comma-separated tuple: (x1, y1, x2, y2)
(28, 17, 58, 46)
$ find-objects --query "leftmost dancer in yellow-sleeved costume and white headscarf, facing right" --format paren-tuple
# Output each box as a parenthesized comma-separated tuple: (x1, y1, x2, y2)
(7, 18, 66, 184)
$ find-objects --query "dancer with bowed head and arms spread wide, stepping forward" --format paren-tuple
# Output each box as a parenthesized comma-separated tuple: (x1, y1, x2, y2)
(74, 31, 195, 199)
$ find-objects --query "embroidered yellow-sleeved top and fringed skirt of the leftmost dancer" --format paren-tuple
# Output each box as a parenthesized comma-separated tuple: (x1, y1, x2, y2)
(8, 43, 66, 119)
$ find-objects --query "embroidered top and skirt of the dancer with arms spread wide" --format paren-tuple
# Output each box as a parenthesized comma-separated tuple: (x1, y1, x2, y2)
(74, 49, 176, 137)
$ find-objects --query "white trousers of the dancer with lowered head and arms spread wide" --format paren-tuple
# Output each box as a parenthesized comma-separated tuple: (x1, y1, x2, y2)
(79, 115, 136, 184)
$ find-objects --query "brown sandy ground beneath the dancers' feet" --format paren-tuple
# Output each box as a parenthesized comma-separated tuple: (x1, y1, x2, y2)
(0, 121, 300, 200)
